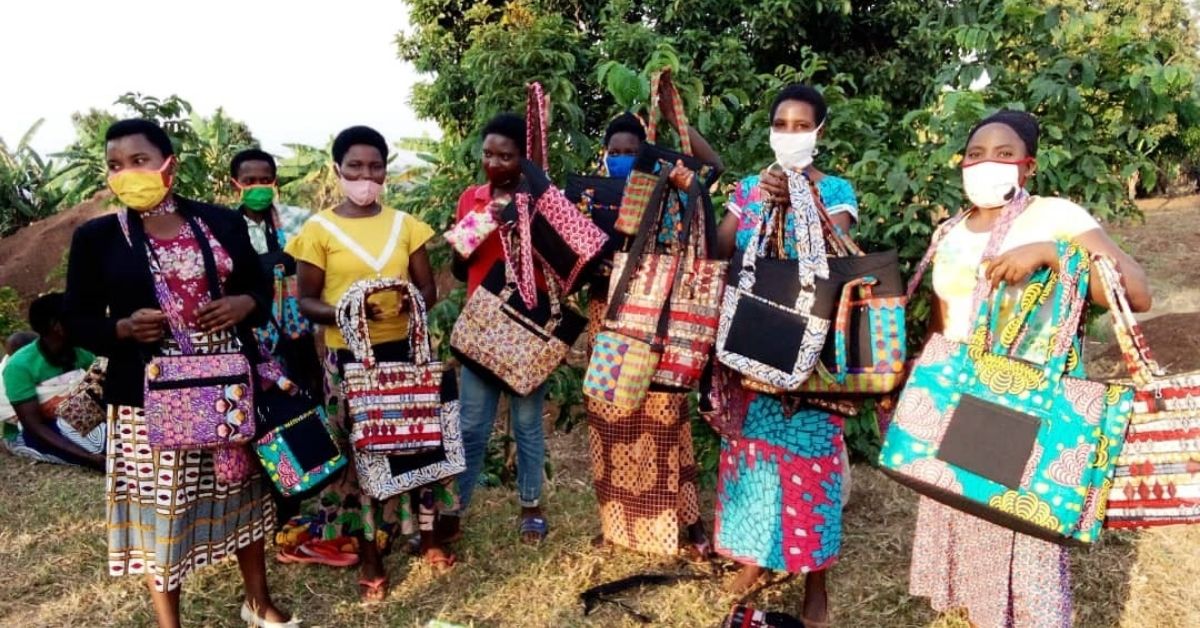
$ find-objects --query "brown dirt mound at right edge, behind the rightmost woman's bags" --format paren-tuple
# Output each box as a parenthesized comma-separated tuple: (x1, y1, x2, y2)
(1088, 312, 1200, 378)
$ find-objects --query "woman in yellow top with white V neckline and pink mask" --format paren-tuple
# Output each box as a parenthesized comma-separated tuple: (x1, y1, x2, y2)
(287, 126, 457, 602)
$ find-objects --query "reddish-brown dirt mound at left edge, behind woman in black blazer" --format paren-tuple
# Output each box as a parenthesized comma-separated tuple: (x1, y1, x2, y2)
(0, 197, 107, 301)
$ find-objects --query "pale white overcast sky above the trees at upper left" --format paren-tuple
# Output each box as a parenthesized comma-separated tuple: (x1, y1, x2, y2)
(0, 0, 437, 154)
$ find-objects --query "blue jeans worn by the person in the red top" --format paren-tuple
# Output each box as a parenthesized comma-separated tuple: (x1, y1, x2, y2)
(450, 366, 546, 515)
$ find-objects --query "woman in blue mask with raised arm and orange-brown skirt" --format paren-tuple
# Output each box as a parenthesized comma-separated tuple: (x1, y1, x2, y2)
(587, 113, 721, 558)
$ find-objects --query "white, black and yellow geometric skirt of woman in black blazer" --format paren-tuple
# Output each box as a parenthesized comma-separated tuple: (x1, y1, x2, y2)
(104, 334, 275, 591)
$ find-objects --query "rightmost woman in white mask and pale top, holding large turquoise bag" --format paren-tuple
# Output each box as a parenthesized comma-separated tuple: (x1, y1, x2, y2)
(910, 110, 1151, 628)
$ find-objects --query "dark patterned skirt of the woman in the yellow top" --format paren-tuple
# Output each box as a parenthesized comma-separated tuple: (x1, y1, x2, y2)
(305, 349, 458, 544)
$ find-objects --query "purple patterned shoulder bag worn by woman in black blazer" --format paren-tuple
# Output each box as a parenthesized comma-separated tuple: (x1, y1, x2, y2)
(133, 211, 256, 451)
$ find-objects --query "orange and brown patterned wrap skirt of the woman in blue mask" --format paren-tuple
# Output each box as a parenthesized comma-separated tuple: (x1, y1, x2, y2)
(587, 300, 700, 556)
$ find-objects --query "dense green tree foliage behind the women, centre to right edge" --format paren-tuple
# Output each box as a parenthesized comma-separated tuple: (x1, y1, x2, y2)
(397, 0, 1200, 465)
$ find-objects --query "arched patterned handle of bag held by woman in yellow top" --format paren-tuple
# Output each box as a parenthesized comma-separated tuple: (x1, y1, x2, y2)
(336, 277, 433, 369)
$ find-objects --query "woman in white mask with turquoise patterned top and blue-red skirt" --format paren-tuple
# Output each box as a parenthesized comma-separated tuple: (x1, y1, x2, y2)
(715, 85, 858, 626)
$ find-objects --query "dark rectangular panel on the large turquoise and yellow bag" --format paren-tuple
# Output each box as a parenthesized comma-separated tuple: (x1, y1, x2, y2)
(937, 395, 1042, 489)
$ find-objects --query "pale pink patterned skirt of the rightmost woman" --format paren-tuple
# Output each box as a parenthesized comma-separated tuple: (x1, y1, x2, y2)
(908, 497, 1072, 628)
